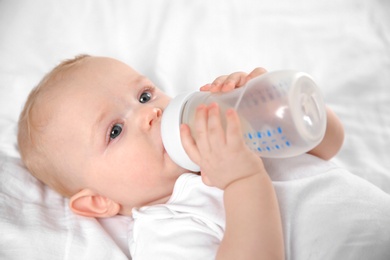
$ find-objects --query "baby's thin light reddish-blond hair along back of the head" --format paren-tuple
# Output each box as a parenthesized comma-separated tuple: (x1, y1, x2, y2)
(18, 54, 90, 197)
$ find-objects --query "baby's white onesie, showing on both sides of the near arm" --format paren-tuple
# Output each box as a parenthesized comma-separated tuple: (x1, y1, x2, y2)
(129, 155, 390, 260)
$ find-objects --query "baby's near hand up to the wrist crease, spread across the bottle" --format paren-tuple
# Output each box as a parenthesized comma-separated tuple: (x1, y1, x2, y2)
(181, 103, 266, 189)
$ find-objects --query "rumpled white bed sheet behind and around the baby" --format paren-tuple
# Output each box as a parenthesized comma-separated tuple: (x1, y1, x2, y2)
(0, 0, 390, 259)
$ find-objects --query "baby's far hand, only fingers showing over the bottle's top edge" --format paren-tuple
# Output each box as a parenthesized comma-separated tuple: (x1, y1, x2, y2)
(200, 67, 267, 92)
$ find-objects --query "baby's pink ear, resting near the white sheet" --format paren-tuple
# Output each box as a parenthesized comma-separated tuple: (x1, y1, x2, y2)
(69, 189, 121, 218)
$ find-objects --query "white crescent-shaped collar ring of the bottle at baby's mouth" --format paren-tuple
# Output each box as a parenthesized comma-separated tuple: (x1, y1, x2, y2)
(161, 92, 200, 172)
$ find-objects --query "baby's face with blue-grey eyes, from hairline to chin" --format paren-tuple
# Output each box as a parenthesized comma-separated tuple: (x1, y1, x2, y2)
(49, 57, 185, 214)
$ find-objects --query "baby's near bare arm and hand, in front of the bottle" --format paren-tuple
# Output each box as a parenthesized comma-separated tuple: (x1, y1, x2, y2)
(181, 104, 284, 259)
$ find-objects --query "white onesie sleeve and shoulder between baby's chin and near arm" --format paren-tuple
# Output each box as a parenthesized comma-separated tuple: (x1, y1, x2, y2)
(129, 173, 225, 260)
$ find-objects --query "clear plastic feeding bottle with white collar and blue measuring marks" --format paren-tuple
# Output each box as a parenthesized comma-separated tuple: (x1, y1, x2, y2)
(161, 70, 326, 171)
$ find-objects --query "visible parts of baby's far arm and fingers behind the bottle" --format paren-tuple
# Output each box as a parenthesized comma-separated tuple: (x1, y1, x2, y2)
(201, 68, 344, 160)
